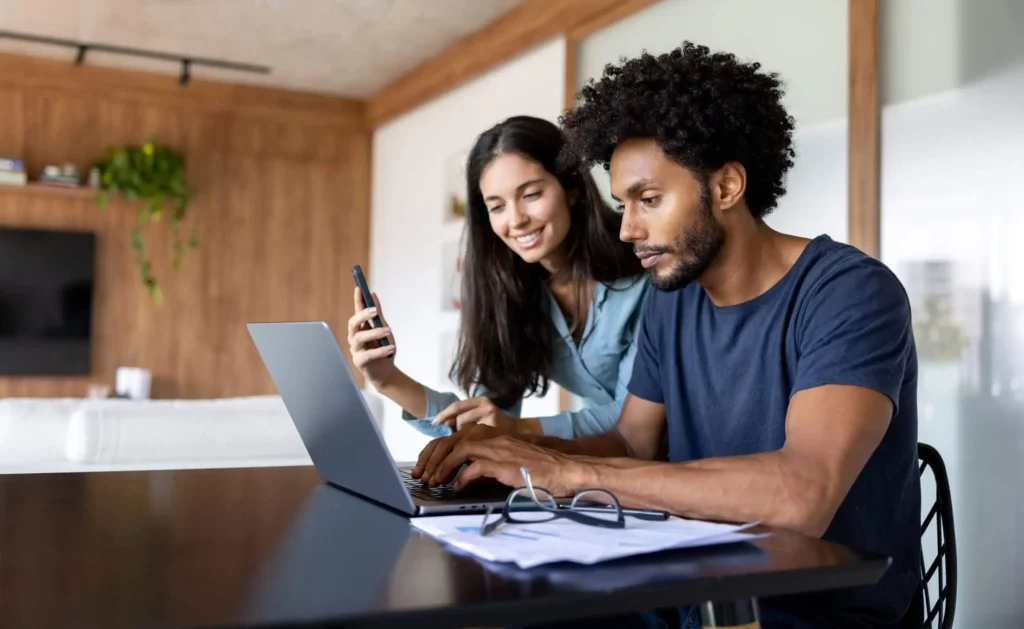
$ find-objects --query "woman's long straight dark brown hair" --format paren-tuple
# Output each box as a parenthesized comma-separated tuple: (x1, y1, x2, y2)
(452, 116, 642, 408)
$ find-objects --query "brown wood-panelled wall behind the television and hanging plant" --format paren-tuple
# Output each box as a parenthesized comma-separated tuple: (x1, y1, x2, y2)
(0, 55, 370, 397)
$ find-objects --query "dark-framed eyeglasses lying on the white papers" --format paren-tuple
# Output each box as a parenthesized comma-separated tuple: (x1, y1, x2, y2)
(480, 467, 668, 535)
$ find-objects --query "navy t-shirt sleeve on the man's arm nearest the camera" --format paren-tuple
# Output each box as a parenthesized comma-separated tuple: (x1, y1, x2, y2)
(793, 259, 913, 415)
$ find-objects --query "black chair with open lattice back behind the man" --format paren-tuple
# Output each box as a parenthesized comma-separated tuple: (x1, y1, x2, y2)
(902, 444, 956, 629)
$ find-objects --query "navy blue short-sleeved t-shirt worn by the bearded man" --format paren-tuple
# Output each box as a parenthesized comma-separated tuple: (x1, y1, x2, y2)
(629, 236, 921, 629)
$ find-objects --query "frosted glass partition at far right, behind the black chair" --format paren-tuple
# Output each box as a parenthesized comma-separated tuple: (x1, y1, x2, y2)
(880, 0, 1024, 629)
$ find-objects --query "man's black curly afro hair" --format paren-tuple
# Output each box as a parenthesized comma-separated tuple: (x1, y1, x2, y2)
(560, 42, 795, 217)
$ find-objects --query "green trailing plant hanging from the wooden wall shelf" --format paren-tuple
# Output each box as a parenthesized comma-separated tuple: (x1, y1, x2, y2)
(94, 139, 199, 303)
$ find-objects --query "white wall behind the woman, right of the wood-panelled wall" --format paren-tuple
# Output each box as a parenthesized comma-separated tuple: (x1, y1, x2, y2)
(369, 38, 565, 461)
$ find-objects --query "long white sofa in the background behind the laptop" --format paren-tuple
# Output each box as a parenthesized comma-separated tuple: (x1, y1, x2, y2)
(0, 392, 391, 473)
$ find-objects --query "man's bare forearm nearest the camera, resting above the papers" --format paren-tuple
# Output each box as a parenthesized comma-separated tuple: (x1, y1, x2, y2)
(573, 451, 835, 537)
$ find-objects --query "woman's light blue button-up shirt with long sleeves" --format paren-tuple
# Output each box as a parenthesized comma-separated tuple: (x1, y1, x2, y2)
(402, 274, 648, 438)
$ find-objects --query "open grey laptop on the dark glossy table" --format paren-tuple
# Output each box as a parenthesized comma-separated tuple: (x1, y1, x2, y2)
(247, 321, 510, 515)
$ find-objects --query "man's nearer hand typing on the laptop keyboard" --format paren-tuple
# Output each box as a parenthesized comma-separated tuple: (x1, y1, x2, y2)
(444, 436, 588, 496)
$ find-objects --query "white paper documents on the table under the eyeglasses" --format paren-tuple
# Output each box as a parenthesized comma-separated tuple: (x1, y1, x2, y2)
(412, 514, 767, 568)
